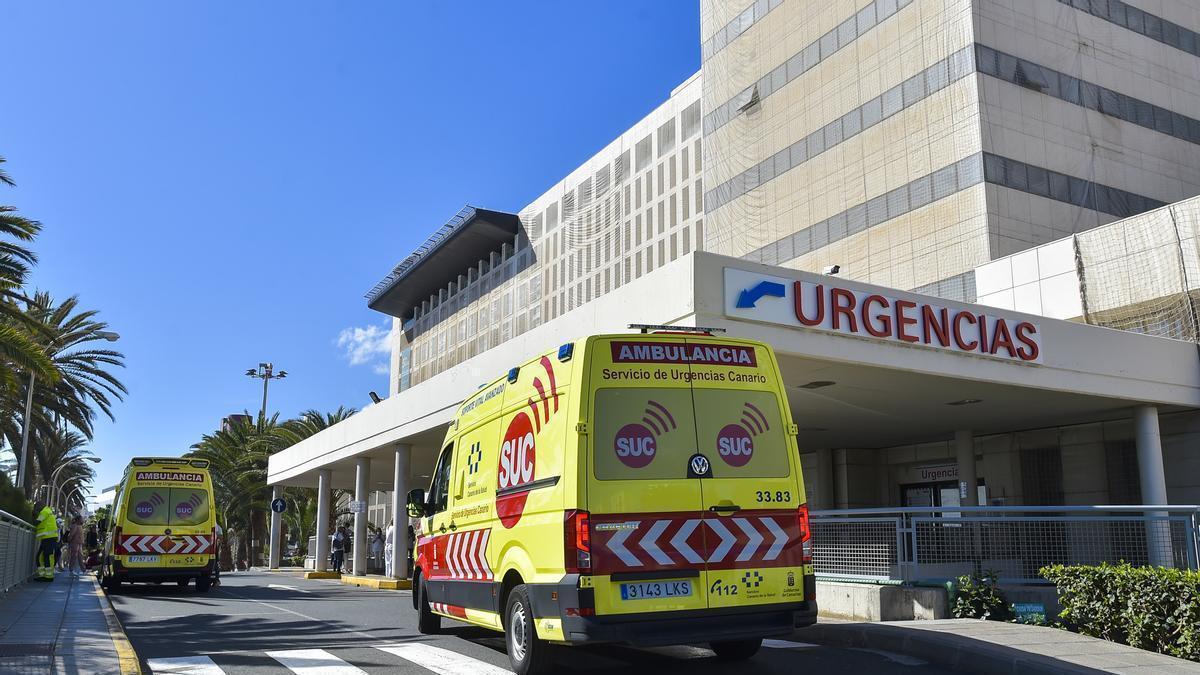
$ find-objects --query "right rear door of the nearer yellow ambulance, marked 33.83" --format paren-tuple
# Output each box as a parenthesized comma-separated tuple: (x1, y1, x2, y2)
(689, 336, 808, 608)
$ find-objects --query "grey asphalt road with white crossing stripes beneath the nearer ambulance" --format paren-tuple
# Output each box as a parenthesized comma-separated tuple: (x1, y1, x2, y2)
(110, 572, 949, 675)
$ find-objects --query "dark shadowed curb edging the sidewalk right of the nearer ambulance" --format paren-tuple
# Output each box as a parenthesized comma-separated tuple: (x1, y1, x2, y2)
(794, 623, 1097, 675)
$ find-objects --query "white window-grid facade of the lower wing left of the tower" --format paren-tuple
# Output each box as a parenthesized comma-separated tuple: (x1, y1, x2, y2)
(397, 97, 703, 390)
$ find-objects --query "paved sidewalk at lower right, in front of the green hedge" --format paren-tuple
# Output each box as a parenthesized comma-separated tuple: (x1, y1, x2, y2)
(796, 619, 1200, 675)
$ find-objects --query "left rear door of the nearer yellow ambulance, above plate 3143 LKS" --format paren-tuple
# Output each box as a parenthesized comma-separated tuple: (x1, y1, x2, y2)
(586, 334, 708, 615)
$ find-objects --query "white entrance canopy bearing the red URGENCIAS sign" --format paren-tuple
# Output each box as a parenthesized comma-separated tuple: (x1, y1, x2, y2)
(268, 252, 1200, 490)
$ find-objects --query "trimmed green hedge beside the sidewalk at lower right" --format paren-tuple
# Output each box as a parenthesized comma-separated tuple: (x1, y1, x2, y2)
(1042, 563, 1200, 661)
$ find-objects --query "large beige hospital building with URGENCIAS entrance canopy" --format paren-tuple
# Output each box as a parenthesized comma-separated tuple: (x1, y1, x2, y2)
(269, 0, 1200, 598)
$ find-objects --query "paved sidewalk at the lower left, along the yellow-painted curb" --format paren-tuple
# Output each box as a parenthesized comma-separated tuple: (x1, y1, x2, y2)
(0, 572, 139, 675)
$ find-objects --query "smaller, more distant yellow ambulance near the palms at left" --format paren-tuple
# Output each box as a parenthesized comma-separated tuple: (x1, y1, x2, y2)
(100, 458, 217, 593)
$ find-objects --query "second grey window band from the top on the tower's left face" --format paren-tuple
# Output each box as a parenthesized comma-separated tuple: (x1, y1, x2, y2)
(704, 0, 912, 136)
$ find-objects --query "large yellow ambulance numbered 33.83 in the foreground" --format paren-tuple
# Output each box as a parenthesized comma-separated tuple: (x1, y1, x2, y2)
(408, 328, 817, 675)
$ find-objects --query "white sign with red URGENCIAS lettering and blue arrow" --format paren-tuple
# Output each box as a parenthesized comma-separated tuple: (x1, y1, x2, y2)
(725, 268, 1042, 363)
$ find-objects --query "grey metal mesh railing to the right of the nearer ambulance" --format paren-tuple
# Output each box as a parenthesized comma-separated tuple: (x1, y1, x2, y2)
(810, 506, 1200, 584)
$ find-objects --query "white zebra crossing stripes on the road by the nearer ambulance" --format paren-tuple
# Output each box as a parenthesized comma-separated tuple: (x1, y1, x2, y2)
(146, 640, 817, 675)
